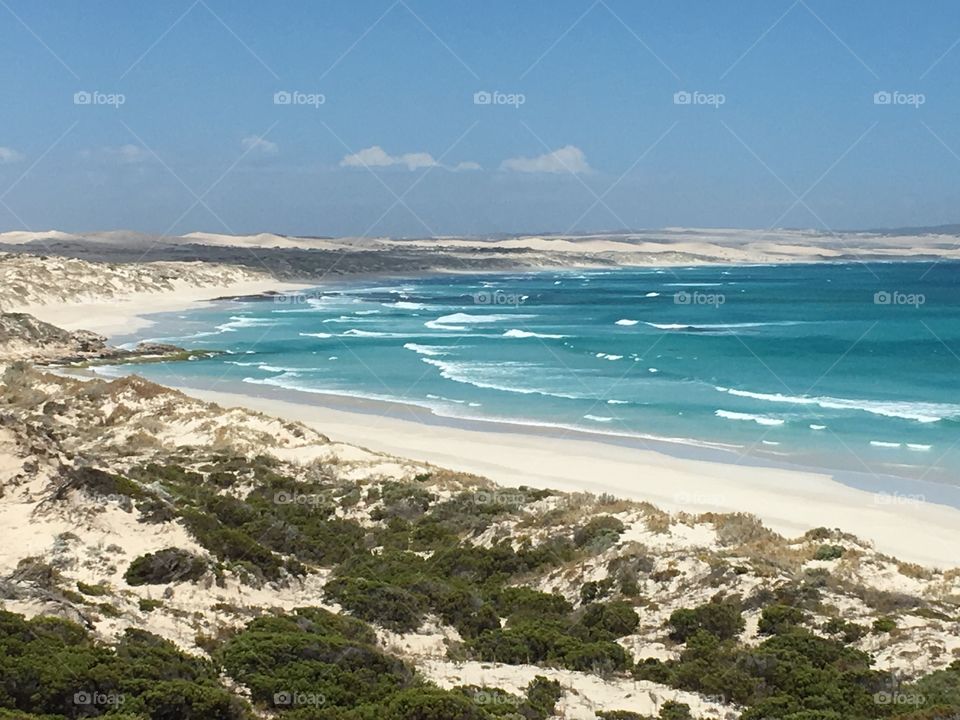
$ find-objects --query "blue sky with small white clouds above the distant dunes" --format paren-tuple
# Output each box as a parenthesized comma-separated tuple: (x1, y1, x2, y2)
(0, 0, 960, 236)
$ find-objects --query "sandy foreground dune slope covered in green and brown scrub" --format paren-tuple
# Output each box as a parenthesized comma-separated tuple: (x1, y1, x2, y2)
(0, 368, 960, 720)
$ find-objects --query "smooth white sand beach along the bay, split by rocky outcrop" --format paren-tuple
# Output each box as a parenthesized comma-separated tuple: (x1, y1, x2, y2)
(15, 280, 960, 567)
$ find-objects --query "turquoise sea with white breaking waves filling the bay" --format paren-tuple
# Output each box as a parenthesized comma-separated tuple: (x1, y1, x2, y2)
(109, 263, 960, 498)
